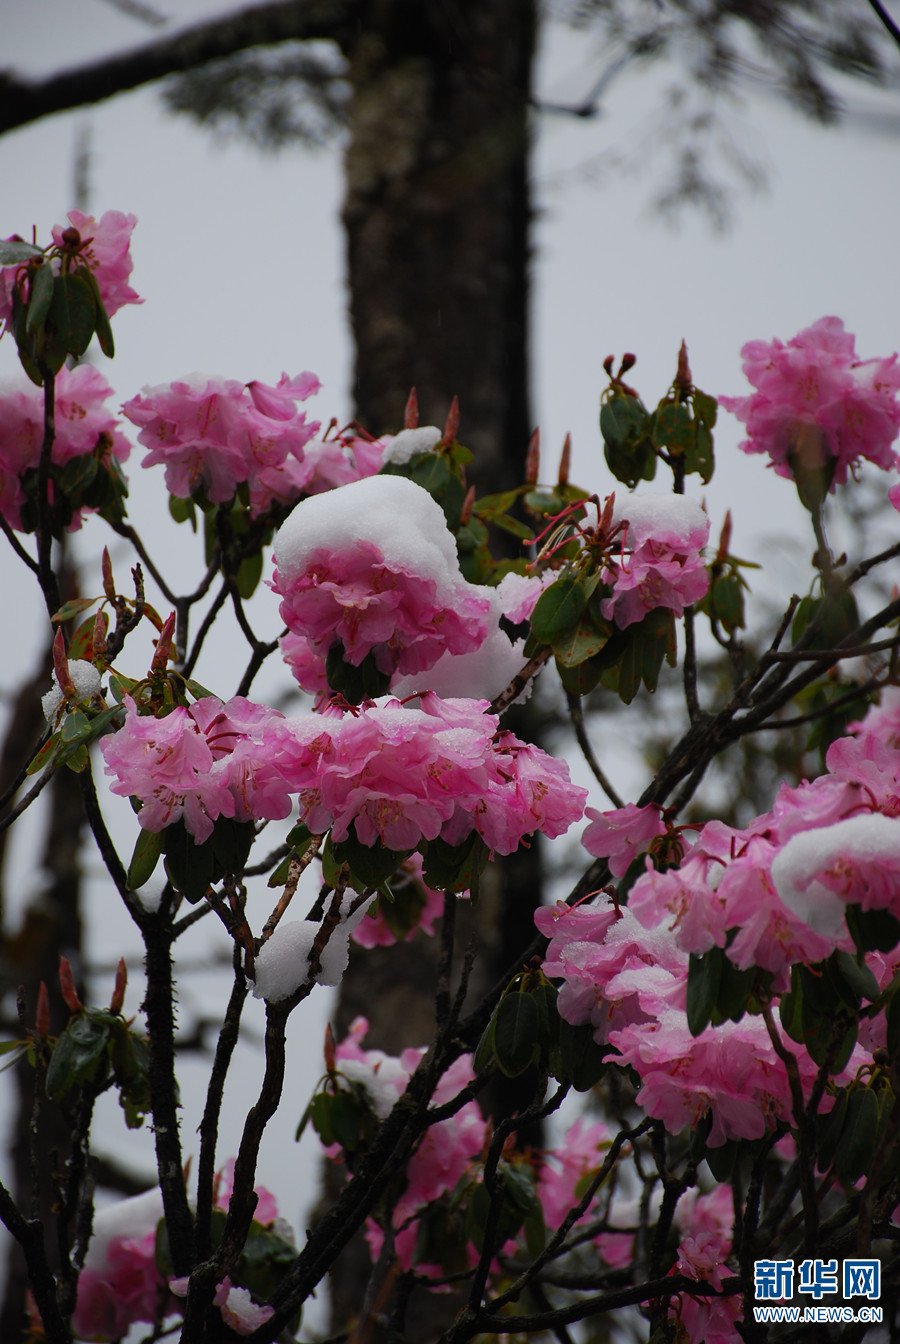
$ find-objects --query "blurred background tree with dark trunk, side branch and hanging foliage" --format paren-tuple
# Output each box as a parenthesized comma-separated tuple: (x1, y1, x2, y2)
(0, 0, 887, 1338)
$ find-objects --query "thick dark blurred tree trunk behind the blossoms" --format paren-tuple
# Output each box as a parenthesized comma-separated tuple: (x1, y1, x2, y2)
(332, 0, 541, 1341)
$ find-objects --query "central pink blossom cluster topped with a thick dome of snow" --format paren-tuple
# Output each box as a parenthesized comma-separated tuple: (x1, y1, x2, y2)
(273, 476, 490, 673)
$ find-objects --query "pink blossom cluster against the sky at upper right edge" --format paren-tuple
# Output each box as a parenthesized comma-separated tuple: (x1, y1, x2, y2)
(719, 317, 900, 491)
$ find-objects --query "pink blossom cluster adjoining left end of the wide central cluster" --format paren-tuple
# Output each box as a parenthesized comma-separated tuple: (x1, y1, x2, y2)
(101, 696, 290, 844)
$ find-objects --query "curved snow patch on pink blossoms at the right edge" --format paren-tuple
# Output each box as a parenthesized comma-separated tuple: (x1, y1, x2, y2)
(772, 812, 900, 938)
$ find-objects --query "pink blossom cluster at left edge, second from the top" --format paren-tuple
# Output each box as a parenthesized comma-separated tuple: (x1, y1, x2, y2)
(0, 364, 130, 530)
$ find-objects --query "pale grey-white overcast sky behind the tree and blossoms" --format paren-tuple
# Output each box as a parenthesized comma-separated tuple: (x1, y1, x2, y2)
(0, 0, 900, 1333)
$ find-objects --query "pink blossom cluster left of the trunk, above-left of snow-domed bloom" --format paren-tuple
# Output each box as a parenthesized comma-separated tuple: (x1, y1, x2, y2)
(122, 374, 334, 516)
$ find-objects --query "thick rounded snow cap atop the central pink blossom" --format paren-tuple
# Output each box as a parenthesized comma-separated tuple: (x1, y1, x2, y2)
(274, 476, 463, 594)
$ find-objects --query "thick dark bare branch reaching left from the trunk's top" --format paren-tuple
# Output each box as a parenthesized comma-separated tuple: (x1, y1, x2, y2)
(0, 0, 359, 134)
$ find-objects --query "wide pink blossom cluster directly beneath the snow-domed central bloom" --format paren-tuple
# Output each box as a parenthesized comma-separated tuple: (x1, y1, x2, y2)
(275, 694, 586, 853)
